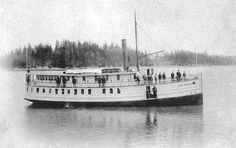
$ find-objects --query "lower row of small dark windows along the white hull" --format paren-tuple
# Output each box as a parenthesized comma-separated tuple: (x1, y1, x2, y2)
(27, 87, 121, 95)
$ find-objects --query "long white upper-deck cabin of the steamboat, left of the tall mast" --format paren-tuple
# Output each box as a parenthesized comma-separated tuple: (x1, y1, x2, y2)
(27, 70, 137, 87)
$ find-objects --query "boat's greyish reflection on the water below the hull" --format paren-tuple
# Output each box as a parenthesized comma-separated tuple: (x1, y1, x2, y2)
(24, 106, 203, 147)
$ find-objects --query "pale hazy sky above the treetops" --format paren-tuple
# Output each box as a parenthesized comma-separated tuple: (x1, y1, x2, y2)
(0, 0, 236, 55)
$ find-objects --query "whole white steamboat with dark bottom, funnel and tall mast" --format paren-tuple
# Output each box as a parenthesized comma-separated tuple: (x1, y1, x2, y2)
(25, 11, 203, 106)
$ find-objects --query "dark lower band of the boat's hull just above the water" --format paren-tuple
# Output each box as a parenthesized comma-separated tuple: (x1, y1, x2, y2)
(25, 94, 203, 107)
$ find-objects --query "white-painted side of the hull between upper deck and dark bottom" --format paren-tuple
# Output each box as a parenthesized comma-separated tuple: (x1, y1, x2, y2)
(25, 79, 202, 103)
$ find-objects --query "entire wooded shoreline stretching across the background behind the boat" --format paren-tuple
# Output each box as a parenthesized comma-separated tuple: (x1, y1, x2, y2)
(1, 40, 236, 68)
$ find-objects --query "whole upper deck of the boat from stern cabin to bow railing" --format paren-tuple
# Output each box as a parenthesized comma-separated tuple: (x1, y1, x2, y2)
(26, 70, 201, 88)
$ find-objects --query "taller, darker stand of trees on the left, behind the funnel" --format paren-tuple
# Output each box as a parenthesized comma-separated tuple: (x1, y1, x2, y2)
(1, 40, 152, 68)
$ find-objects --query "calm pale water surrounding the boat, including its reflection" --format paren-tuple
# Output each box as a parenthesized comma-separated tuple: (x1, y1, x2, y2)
(0, 66, 236, 148)
